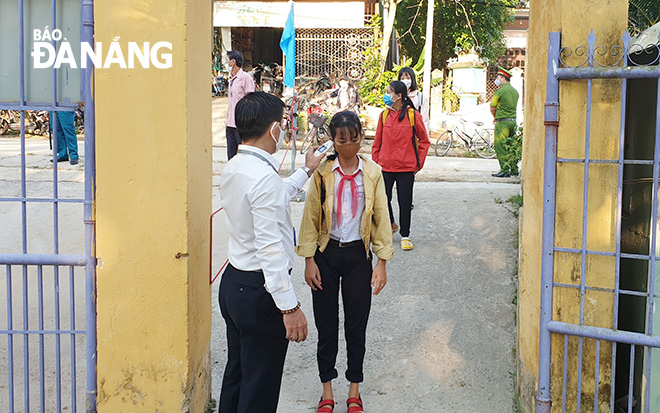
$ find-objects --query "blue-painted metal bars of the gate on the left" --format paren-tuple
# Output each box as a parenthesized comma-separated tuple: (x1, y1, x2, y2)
(0, 0, 97, 412)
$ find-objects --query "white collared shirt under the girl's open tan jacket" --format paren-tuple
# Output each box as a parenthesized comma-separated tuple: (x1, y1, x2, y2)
(330, 157, 364, 242)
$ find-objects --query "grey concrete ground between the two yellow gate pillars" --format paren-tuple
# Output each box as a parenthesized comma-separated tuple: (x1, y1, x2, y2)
(211, 96, 520, 413)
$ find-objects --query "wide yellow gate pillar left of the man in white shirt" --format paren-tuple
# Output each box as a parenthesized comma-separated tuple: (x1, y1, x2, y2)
(94, 0, 212, 413)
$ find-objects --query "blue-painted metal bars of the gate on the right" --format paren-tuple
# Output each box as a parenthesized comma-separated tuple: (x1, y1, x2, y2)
(536, 32, 660, 413)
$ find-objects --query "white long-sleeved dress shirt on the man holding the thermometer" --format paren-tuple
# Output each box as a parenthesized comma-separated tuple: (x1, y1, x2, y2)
(220, 145, 308, 310)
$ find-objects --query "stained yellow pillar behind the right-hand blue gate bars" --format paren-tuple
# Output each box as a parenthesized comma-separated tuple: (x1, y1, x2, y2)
(517, 0, 627, 412)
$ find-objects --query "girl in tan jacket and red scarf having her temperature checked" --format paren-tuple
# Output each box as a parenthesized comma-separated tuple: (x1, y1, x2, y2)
(296, 111, 394, 413)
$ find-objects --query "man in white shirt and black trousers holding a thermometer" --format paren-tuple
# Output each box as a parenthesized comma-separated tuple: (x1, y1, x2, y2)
(218, 92, 323, 413)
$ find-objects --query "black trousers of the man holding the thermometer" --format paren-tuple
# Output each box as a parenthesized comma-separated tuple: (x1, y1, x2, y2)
(218, 264, 289, 413)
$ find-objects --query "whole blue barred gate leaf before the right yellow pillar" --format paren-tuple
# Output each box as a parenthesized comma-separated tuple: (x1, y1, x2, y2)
(536, 31, 660, 413)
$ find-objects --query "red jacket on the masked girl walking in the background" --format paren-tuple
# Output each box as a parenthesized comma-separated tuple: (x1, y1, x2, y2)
(371, 109, 431, 172)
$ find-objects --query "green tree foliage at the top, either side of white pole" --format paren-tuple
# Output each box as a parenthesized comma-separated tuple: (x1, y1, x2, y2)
(395, 0, 521, 68)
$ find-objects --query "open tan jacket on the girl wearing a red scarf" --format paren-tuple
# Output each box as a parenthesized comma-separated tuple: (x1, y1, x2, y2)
(296, 155, 394, 260)
